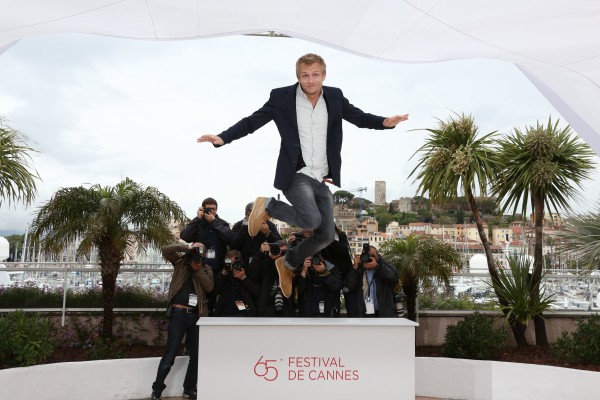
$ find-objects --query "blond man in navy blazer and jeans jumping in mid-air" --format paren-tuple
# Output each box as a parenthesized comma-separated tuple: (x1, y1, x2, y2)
(198, 54, 408, 297)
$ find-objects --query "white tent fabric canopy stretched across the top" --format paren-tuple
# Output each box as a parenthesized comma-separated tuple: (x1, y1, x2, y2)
(0, 0, 600, 154)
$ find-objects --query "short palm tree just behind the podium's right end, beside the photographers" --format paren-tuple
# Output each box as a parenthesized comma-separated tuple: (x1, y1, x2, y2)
(380, 234, 462, 321)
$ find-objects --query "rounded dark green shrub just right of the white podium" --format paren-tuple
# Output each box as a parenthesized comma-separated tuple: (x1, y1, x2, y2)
(442, 312, 508, 360)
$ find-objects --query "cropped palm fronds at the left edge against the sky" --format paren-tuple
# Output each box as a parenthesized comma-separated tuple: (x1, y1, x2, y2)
(0, 115, 40, 206)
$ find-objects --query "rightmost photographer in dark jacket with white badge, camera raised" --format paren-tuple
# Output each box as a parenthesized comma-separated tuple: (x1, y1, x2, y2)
(344, 244, 399, 318)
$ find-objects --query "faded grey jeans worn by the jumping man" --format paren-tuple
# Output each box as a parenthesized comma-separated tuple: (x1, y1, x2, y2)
(267, 173, 335, 269)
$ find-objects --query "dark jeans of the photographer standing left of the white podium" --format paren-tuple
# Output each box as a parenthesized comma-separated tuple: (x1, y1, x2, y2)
(152, 308, 198, 393)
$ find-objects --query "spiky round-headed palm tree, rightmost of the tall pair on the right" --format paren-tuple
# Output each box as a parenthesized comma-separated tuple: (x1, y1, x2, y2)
(494, 117, 595, 346)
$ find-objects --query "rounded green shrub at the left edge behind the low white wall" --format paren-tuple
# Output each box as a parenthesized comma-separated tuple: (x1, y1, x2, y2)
(0, 310, 52, 367)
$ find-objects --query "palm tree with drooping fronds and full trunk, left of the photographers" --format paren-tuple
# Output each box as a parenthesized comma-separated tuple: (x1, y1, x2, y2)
(31, 178, 185, 340)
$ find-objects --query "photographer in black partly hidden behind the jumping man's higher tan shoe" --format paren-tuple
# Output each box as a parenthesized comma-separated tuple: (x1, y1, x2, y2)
(229, 203, 281, 265)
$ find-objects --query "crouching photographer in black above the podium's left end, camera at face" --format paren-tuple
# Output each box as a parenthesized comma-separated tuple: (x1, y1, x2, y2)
(212, 250, 260, 317)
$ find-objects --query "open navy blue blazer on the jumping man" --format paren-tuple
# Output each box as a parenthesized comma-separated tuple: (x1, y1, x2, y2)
(219, 83, 386, 190)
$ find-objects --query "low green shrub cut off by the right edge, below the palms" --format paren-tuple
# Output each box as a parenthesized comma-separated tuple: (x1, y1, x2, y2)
(550, 314, 600, 364)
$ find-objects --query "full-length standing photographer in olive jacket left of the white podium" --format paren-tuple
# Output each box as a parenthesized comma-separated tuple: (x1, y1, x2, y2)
(151, 242, 214, 400)
